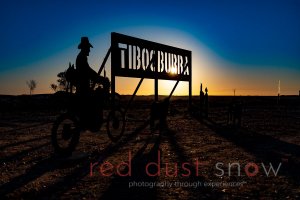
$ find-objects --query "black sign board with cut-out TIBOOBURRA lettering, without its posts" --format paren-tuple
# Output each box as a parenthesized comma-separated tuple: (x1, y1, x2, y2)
(111, 33, 192, 81)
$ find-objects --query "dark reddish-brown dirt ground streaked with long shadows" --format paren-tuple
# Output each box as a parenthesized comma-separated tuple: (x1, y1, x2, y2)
(0, 97, 300, 199)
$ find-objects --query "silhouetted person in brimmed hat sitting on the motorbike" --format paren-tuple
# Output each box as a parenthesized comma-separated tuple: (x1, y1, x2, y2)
(76, 37, 110, 131)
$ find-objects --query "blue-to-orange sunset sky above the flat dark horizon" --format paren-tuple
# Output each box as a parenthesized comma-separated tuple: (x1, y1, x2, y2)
(0, 0, 300, 95)
